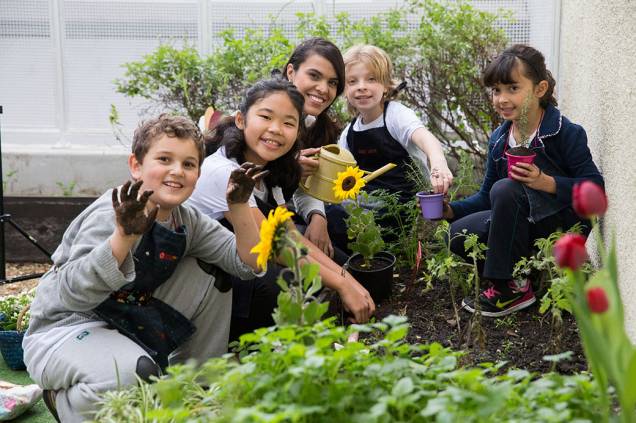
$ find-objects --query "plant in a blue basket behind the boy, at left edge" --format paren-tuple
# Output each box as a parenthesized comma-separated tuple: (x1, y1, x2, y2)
(0, 290, 34, 370)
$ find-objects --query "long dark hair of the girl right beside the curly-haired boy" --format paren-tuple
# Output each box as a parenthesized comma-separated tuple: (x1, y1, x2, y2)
(206, 78, 305, 197)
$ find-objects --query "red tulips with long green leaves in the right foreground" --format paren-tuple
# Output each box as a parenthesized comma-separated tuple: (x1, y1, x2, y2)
(554, 185, 636, 423)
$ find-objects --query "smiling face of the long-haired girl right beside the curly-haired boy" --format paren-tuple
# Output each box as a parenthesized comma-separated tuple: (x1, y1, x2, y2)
(235, 91, 300, 165)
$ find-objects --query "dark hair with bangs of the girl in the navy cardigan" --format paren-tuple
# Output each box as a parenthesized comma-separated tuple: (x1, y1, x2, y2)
(483, 44, 557, 108)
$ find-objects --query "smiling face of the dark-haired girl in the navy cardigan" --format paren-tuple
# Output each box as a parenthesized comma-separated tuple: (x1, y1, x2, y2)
(490, 64, 547, 122)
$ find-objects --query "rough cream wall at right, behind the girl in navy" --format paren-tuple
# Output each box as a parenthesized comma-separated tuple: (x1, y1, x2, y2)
(557, 0, 636, 340)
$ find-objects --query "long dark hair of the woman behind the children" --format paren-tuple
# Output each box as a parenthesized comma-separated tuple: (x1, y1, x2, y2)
(283, 37, 345, 148)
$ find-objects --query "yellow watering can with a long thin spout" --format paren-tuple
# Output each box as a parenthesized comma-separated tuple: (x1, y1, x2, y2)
(300, 144, 396, 204)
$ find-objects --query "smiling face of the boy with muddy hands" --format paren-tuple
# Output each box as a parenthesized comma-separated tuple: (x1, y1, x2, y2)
(128, 134, 200, 220)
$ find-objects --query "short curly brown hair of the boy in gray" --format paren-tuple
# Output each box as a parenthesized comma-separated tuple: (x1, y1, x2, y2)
(132, 113, 205, 165)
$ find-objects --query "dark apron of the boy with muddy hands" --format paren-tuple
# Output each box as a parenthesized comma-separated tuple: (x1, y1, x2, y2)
(94, 222, 196, 369)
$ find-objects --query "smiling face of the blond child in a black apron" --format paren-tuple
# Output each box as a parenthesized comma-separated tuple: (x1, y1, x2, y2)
(345, 62, 387, 123)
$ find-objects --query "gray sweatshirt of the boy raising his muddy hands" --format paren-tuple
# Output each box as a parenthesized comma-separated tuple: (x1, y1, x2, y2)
(26, 190, 254, 337)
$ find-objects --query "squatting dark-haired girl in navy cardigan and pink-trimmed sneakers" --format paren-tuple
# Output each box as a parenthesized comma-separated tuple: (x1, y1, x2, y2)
(444, 44, 603, 317)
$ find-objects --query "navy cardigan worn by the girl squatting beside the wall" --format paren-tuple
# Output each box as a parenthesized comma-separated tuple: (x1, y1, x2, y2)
(450, 104, 604, 220)
